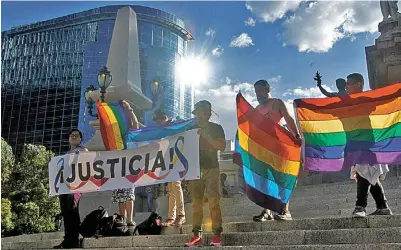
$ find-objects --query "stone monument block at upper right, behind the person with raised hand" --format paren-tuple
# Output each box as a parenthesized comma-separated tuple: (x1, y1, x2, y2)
(365, 16, 401, 89)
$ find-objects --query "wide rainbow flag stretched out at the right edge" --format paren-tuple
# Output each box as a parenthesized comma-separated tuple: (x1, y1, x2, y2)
(294, 83, 401, 171)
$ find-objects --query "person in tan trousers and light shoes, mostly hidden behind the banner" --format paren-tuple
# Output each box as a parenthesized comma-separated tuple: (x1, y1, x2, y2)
(152, 109, 185, 226)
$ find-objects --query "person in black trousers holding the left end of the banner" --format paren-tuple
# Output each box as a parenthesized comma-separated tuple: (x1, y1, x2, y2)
(53, 129, 88, 249)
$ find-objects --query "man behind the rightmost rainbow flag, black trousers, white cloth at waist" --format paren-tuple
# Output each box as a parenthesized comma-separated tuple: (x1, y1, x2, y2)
(346, 73, 393, 217)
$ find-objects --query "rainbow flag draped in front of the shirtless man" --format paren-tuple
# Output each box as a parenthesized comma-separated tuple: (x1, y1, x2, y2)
(234, 93, 301, 213)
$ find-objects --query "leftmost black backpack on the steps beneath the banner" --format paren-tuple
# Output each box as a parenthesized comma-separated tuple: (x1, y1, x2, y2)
(79, 206, 109, 238)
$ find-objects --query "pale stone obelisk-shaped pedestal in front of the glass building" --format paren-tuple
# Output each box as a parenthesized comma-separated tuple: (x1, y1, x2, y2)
(80, 6, 152, 218)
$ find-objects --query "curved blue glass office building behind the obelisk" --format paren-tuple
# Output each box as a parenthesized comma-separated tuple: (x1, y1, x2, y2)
(1, 5, 193, 154)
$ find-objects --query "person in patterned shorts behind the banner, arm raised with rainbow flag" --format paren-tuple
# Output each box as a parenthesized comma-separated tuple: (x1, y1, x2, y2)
(111, 101, 139, 226)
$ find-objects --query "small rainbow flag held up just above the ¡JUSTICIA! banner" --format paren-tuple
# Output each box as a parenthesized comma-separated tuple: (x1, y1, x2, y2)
(96, 101, 129, 150)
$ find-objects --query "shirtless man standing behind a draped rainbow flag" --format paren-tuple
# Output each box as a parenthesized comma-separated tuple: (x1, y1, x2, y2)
(253, 80, 300, 221)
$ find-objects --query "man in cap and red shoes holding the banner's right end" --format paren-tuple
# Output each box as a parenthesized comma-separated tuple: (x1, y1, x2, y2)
(186, 100, 226, 247)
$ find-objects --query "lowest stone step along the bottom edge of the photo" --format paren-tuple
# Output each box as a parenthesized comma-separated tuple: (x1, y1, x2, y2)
(2, 227, 401, 249)
